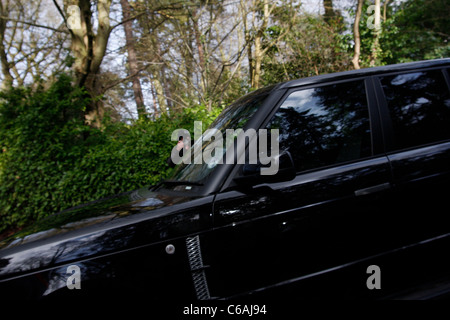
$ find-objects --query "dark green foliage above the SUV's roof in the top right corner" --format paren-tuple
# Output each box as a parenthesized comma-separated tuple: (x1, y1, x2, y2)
(360, 0, 450, 67)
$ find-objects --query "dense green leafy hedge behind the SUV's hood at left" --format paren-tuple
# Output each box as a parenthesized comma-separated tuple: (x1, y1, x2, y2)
(0, 75, 220, 232)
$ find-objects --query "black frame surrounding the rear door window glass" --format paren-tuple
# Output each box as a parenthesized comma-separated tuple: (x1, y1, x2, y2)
(371, 66, 450, 155)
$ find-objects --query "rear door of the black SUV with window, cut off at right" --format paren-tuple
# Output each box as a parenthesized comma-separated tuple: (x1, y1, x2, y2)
(376, 68, 450, 279)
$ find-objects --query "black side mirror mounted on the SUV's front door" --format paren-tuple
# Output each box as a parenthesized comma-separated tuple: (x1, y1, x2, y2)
(234, 151, 296, 186)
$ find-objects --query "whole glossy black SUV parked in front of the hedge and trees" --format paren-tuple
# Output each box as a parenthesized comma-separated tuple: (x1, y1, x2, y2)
(0, 59, 450, 304)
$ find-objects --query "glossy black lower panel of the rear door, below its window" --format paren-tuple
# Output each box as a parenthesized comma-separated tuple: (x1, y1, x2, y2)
(388, 142, 450, 240)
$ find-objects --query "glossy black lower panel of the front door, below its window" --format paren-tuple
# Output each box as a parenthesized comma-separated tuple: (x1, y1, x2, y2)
(206, 157, 394, 296)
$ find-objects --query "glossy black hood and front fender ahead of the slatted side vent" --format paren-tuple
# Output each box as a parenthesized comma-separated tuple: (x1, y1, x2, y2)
(0, 188, 213, 299)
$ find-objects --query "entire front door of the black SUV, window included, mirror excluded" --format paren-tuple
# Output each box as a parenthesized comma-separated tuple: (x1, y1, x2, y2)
(208, 79, 393, 297)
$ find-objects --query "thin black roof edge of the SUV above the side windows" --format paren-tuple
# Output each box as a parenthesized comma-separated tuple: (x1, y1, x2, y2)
(276, 58, 450, 89)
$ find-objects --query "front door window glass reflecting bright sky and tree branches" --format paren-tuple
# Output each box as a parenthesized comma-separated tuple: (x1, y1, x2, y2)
(267, 80, 371, 171)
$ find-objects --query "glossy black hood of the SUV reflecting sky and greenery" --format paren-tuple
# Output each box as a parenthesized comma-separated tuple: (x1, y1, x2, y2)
(0, 187, 212, 280)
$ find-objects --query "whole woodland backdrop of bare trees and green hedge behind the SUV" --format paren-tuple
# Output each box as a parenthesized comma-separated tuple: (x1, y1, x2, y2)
(0, 0, 450, 238)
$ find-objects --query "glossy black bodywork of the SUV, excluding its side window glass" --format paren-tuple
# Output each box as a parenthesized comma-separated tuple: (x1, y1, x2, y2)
(0, 59, 450, 304)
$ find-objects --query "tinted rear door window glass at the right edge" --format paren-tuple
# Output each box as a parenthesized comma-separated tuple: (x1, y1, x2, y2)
(380, 70, 450, 149)
